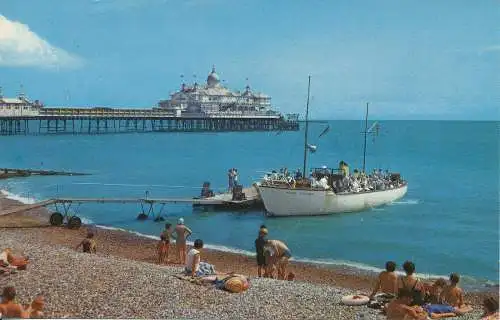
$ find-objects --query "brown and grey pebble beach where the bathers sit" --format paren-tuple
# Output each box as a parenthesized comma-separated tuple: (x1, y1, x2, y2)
(0, 198, 492, 319)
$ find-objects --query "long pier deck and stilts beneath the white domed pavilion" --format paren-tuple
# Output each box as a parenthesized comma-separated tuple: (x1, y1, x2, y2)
(0, 107, 299, 135)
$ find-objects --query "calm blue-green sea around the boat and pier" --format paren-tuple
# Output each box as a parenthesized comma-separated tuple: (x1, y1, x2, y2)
(0, 121, 500, 287)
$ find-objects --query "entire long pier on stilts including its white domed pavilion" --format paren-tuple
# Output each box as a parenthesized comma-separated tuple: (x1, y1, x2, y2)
(0, 68, 299, 135)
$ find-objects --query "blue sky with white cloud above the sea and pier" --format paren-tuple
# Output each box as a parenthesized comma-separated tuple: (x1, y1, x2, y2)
(0, 0, 500, 120)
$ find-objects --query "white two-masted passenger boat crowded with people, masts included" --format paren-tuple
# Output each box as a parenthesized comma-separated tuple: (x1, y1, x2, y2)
(256, 77, 408, 216)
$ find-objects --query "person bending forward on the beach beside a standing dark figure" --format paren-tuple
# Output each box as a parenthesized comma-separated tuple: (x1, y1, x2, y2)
(264, 240, 292, 280)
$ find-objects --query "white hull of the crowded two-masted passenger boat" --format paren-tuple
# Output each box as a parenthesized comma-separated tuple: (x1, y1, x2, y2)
(258, 184, 408, 216)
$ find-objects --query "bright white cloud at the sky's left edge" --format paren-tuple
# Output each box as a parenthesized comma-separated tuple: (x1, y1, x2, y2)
(0, 15, 82, 68)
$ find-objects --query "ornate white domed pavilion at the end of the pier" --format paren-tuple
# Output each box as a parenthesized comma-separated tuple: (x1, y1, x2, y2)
(158, 67, 279, 116)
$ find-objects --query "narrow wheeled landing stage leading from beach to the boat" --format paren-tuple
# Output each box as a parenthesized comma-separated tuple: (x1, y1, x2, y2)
(0, 186, 262, 228)
